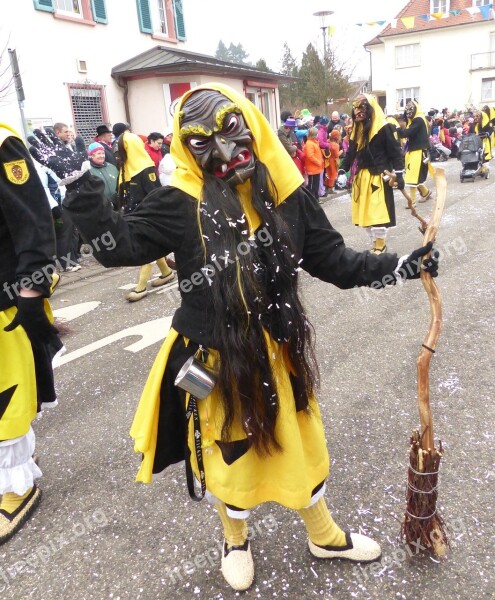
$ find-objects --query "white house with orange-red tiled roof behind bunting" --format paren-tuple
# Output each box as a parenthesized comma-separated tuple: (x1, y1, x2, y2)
(365, 0, 495, 113)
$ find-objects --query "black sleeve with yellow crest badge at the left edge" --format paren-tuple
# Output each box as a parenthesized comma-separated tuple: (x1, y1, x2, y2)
(0, 136, 55, 297)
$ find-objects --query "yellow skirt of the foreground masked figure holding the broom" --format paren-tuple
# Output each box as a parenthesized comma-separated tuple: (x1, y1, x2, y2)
(130, 329, 329, 509)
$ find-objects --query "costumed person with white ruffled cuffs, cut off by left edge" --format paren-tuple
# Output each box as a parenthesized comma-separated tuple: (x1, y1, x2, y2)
(0, 123, 62, 544)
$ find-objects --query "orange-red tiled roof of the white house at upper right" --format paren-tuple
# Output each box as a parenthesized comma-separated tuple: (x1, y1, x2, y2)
(364, 0, 492, 46)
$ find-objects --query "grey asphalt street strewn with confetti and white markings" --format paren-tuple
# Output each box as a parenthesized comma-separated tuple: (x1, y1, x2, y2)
(0, 160, 495, 600)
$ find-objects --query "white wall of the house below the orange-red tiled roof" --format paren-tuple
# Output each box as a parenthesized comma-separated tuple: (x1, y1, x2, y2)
(369, 21, 495, 112)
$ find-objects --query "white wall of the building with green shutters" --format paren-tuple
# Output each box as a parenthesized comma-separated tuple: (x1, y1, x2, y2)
(0, 0, 182, 136)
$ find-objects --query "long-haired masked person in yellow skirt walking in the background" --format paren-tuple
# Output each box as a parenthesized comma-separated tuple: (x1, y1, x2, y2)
(339, 94, 404, 254)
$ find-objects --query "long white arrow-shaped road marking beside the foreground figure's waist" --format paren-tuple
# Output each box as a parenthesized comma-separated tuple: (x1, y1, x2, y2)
(57, 317, 172, 367)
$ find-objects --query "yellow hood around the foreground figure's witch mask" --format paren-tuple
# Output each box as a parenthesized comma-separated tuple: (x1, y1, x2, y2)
(170, 83, 304, 202)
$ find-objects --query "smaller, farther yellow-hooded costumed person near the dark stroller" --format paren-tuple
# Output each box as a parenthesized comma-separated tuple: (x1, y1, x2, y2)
(397, 100, 431, 208)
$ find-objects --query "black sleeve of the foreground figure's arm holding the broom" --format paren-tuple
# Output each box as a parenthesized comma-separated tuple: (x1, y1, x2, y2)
(284, 188, 398, 289)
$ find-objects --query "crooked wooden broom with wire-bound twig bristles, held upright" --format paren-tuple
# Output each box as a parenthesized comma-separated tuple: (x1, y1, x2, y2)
(402, 168, 448, 556)
